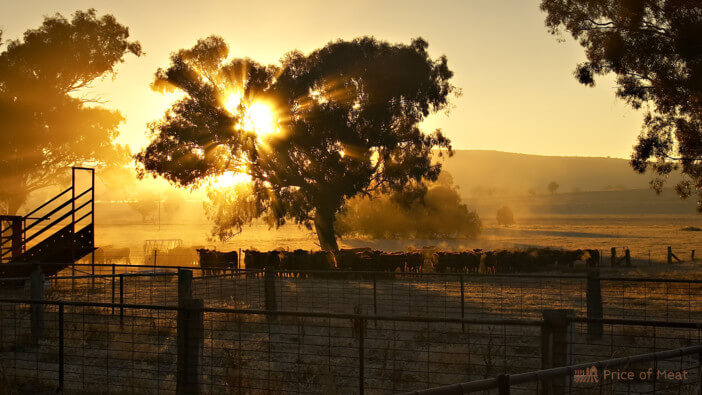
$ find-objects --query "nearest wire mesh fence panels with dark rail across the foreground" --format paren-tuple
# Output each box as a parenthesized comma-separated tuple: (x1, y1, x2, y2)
(0, 294, 702, 393)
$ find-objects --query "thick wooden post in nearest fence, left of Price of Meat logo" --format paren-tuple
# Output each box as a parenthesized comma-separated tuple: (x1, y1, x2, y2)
(539, 310, 574, 395)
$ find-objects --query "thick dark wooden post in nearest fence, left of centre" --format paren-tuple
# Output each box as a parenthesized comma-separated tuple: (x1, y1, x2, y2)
(176, 299, 204, 395)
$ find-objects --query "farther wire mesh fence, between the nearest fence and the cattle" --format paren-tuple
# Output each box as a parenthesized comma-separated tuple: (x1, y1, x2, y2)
(0, 265, 702, 321)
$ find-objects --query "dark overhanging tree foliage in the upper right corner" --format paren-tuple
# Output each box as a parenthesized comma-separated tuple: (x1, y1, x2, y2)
(541, 0, 702, 211)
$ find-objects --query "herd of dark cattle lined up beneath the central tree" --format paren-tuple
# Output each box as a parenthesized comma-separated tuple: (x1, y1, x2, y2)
(197, 248, 600, 274)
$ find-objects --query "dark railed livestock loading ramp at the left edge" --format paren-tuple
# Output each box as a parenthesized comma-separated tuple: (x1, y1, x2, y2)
(0, 167, 95, 277)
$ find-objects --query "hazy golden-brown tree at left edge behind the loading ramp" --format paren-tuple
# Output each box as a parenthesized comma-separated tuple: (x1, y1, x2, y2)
(0, 9, 142, 214)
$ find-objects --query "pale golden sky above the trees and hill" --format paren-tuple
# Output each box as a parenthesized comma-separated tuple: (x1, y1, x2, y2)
(0, 0, 642, 157)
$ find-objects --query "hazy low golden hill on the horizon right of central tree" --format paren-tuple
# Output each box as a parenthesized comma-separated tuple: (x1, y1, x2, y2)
(444, 150, 696, 218)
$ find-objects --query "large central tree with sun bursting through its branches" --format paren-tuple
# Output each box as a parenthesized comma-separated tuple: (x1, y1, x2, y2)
(137, 37, 455, 250)
